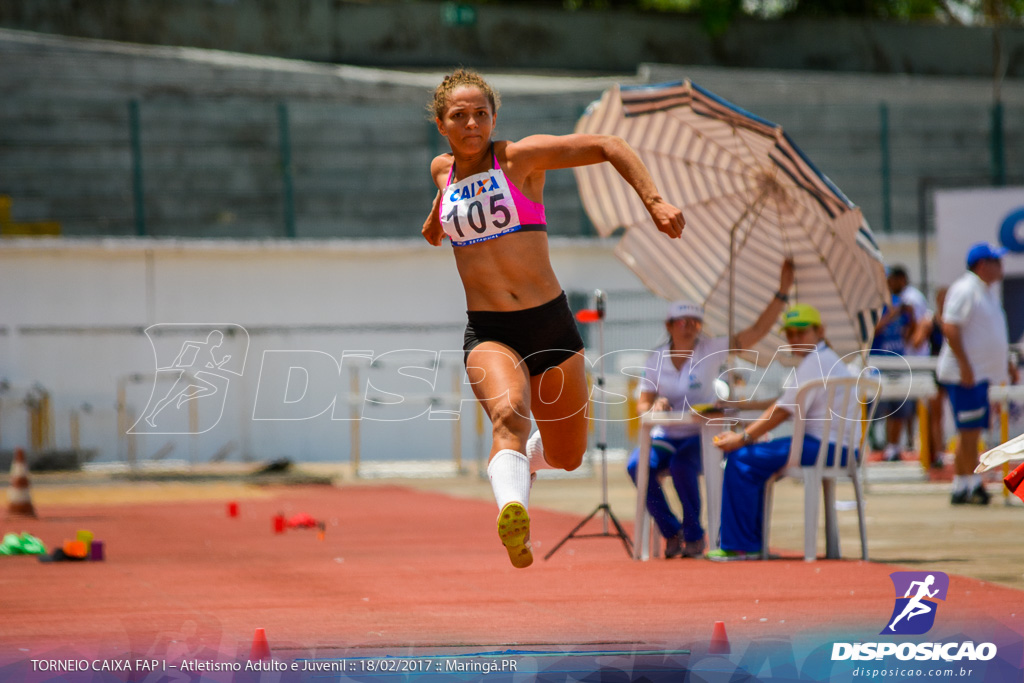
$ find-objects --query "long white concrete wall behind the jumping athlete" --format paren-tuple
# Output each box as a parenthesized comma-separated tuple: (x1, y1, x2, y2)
(0, 233, 934, 462)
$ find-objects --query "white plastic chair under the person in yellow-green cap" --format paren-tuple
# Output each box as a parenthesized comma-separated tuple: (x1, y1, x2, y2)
(761, 377, 879, 562)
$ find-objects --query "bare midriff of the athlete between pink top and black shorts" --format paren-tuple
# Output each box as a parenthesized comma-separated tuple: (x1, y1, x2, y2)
(453, 232, 562, 310)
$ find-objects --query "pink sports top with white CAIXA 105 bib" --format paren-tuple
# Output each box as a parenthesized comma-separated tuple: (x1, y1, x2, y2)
(438, 143, 548, 247)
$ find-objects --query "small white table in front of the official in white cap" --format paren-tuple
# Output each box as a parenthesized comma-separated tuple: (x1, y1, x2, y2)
(633, 411, 738, 560)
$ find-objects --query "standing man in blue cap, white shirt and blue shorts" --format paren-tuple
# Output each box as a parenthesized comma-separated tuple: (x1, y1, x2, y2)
(935, 242, 1017, 505)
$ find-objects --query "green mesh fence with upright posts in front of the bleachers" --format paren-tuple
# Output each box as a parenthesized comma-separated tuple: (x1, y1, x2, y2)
(0, 94, 1024, 239)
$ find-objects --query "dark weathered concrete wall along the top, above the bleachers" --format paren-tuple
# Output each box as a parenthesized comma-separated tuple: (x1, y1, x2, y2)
(0, 0, 1024, 78)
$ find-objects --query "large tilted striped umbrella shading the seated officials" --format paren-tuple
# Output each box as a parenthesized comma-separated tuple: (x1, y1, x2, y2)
(575, 81, 889, 362)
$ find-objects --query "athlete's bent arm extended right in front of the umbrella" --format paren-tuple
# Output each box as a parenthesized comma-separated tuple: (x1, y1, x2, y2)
(505, 133, 686, 238)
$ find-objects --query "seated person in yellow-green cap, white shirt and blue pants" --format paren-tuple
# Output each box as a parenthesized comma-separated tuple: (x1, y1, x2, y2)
(708, 304, 860, 561)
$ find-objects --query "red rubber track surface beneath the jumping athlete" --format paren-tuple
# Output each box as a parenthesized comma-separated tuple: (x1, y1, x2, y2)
(0, 485, 1024, 658)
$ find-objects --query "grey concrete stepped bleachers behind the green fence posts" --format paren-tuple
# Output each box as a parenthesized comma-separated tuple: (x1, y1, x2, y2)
(0, 30, 1024, 238)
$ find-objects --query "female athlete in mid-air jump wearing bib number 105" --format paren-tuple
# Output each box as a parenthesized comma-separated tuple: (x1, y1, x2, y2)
(422, 70, 685, 567)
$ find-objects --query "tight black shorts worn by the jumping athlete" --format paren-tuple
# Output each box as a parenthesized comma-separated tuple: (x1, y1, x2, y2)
(462, 292, 583, 377)
